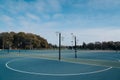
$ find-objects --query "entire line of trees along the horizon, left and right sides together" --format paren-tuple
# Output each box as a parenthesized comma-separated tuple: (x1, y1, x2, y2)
(0, 32, 120, 50)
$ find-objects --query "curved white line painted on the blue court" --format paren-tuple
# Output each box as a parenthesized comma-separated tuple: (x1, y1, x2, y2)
(5, 59, 112, 76)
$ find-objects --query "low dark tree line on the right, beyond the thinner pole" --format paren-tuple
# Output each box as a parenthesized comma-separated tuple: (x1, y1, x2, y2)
(68, 41, 120, 50)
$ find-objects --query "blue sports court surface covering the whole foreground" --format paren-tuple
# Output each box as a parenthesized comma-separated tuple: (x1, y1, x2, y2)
(0, 50, 120, 80)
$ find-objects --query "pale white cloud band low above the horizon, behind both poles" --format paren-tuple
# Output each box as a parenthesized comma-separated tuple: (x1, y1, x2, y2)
(29, 27, 120, 45)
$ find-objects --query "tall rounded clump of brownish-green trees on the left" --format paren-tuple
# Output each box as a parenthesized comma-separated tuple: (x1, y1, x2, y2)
(0, 32, 49, 49)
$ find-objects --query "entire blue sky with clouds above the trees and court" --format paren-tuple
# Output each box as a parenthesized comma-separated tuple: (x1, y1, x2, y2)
(0, 0, 120, 45)
